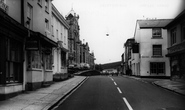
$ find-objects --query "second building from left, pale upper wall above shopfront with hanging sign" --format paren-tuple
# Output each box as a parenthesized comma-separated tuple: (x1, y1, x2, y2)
(23, 0, 58, 90)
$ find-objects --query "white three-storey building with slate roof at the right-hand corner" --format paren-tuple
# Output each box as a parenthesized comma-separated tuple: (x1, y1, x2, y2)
(131, 19, 171, 77)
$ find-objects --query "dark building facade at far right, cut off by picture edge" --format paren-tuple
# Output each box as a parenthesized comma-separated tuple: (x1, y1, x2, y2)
(165, 10, 185, 80)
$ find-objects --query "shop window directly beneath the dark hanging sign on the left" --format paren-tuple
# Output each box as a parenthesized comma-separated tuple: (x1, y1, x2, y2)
(27, 51, 41, 69)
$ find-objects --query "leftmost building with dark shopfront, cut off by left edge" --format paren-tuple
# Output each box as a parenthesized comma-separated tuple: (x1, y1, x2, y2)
(0, 0, 28, 100)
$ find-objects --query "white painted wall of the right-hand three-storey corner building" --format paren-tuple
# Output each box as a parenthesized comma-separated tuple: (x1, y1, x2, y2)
(132, 24, 170, 76)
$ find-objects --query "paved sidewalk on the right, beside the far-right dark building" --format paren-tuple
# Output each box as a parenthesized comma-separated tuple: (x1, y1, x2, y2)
(124, 75, 185, 96)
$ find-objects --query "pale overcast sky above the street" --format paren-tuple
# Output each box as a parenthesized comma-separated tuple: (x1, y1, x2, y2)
(52, 0, 185, 64)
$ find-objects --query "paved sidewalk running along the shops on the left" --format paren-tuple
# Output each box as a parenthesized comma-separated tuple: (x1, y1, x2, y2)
(0, 76, 87, 110)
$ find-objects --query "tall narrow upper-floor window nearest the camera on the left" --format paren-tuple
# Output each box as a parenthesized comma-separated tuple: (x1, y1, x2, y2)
(26, 3, 33, 29)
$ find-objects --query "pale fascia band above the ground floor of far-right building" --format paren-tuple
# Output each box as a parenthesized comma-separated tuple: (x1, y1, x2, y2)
(168, 41, 185, 54)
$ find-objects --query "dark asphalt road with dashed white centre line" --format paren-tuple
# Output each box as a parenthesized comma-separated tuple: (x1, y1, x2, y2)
(53, 76, 185, 110)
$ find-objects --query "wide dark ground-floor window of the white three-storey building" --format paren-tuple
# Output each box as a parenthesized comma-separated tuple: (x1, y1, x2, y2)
(150, 62, 165, 74)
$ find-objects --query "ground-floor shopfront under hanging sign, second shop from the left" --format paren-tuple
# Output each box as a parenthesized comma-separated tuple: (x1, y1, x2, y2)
(26, 31, 57, 90)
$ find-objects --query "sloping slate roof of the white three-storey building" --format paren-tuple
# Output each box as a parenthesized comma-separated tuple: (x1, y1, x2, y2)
(137, 19, 172, 28)
